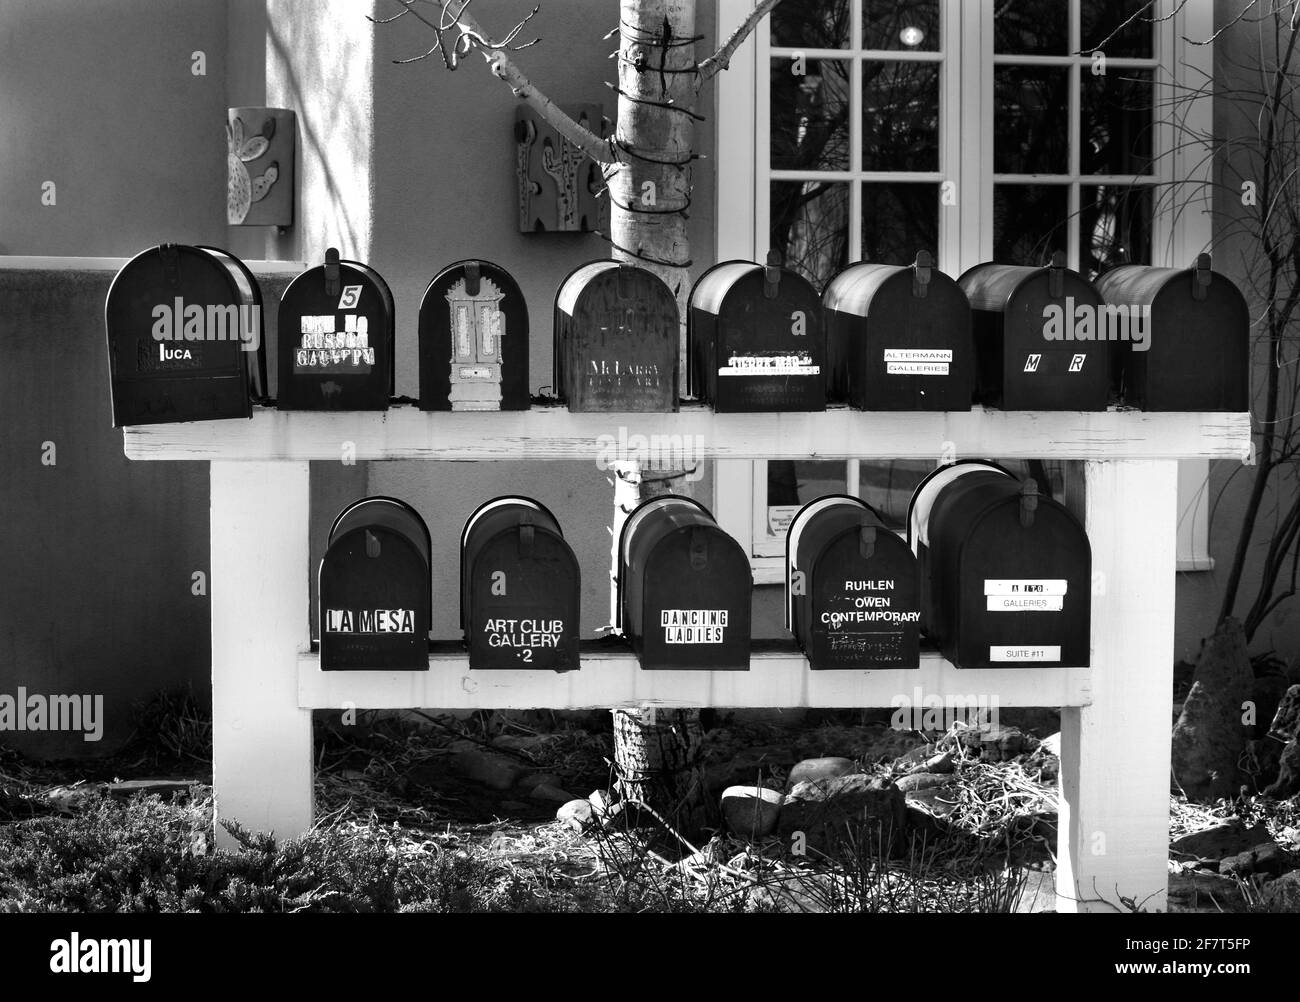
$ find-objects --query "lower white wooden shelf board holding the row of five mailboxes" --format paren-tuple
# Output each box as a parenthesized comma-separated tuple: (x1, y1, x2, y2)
(298, 651, 1092, 710)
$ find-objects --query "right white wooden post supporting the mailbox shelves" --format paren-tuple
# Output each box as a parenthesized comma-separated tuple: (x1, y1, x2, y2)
(1057, 460, 1178, 911)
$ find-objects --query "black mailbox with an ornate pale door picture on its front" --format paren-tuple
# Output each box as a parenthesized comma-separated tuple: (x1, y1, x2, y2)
(420, 261, 529, 411)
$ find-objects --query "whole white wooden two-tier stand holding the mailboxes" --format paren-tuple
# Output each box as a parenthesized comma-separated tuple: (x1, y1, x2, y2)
(124, 407, 1251, 911)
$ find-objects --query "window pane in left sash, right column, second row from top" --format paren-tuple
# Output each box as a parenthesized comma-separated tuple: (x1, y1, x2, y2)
(862, 60, 939, 170)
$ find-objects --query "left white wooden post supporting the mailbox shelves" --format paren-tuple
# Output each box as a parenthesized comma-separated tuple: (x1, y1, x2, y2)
(209, 460, 315, 847)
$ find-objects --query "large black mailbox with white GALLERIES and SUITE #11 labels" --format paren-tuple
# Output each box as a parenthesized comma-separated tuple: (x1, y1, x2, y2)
(922, 470, 1092, 668)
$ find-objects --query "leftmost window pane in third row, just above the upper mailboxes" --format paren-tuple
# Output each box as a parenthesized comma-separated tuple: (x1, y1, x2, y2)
(768, 181, 849, 290)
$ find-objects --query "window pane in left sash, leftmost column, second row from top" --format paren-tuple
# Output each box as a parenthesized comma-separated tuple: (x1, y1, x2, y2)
(771, 57, 849, 170)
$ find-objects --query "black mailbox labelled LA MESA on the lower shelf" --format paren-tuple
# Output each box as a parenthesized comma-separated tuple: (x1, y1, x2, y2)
(319, 496, 433, 672)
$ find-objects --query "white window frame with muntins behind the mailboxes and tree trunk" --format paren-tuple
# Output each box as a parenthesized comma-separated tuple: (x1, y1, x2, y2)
(714, 0, 1214, 584)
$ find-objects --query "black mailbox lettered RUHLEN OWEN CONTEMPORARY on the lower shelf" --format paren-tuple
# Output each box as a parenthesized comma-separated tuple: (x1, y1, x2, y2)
(785, 495, 920, 669)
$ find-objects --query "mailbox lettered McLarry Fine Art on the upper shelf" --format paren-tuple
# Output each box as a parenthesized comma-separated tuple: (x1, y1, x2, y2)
(555, 261, 680, 412)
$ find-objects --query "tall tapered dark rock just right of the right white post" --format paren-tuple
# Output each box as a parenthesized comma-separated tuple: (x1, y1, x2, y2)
(1173, 619, 1255, 799)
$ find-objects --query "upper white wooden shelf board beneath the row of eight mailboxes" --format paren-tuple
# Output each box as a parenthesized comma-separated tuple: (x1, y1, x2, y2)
(122, 404, 1251, 464)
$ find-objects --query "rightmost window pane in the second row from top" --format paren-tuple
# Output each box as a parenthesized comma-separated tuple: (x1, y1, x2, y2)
(1079, 69, 1152, 174)
